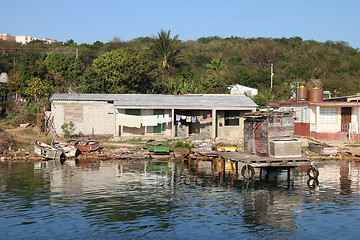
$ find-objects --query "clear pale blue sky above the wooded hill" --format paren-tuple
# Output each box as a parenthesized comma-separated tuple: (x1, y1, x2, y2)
(0, 0, 360, 48)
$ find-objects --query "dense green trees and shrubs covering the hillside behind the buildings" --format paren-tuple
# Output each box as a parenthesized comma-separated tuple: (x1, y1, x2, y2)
(0, 30, 360, 129)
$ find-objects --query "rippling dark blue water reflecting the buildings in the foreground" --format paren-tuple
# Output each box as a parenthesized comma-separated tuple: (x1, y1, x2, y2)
(0, 160, 360, 239)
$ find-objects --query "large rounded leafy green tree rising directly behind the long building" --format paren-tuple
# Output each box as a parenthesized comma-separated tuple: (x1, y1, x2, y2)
(82, 48, 158, 93)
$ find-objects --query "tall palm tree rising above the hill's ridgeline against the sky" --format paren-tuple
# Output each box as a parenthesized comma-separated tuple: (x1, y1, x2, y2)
(154, 29, 182, 75)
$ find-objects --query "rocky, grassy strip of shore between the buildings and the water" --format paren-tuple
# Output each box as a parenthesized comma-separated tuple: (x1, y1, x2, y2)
(0, 127, 360, 162)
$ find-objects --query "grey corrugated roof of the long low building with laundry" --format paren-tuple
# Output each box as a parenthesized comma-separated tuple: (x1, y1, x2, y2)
(50, 93, 257, 108)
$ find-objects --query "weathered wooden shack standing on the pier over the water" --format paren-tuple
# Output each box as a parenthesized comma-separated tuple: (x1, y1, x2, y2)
(244, 111, 301, 157)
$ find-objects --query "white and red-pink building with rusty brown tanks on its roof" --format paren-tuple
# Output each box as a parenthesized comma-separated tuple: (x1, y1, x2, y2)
(279, 89, 360, 142)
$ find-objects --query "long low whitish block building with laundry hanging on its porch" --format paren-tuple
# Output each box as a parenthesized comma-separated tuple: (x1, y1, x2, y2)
(51, 93, 257, 139)
